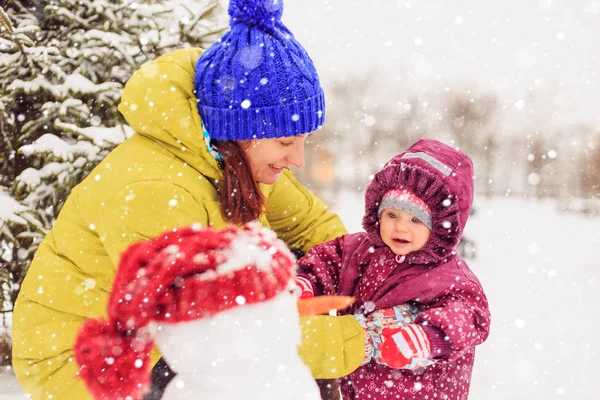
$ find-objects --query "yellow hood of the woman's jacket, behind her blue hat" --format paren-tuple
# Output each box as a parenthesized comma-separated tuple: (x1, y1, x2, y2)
(119, 48, 222, 179)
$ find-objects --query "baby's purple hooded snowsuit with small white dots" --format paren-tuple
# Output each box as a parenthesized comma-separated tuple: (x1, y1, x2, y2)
(299, 139, 490, 400)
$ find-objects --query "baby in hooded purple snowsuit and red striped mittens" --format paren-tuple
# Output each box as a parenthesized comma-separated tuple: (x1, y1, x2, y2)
(296, 139, 490, 400)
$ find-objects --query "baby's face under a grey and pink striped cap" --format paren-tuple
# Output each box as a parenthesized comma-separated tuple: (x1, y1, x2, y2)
(379, 208, 431, 256)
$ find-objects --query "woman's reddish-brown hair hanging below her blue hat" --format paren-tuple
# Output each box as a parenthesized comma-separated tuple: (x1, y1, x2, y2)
(216, 140, 265, 225)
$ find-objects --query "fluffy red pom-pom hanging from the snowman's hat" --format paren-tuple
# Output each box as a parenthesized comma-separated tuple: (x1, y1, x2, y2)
(74, 319, 152, 400)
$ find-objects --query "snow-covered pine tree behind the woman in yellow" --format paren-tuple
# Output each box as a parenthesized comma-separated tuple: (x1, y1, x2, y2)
(0, 0, 227, 338)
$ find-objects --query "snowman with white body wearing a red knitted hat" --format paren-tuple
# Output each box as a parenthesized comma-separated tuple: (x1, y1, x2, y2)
(75, 224, 332, 400)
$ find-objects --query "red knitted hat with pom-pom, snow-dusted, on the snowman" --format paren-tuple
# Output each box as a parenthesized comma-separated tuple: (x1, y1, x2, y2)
(74, 224, 296, 400)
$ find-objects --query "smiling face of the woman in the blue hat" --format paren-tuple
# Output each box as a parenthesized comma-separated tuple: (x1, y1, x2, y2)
(238, 134, 308, 185)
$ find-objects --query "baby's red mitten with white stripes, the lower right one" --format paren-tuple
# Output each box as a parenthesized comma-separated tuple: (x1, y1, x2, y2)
(375, 324, 433, 369)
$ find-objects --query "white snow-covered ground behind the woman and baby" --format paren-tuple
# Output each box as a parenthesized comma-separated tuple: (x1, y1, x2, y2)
(0, 193, 600, 400)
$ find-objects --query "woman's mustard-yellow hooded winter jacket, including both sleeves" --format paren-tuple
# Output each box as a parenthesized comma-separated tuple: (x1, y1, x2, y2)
(13, 49, 362, 400)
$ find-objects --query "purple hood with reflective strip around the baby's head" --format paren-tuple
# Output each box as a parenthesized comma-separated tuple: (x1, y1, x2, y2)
(363, 139, 474, 264)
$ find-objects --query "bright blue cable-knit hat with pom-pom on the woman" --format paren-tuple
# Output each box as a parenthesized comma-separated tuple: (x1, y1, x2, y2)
(194, 0, 325, 140)
